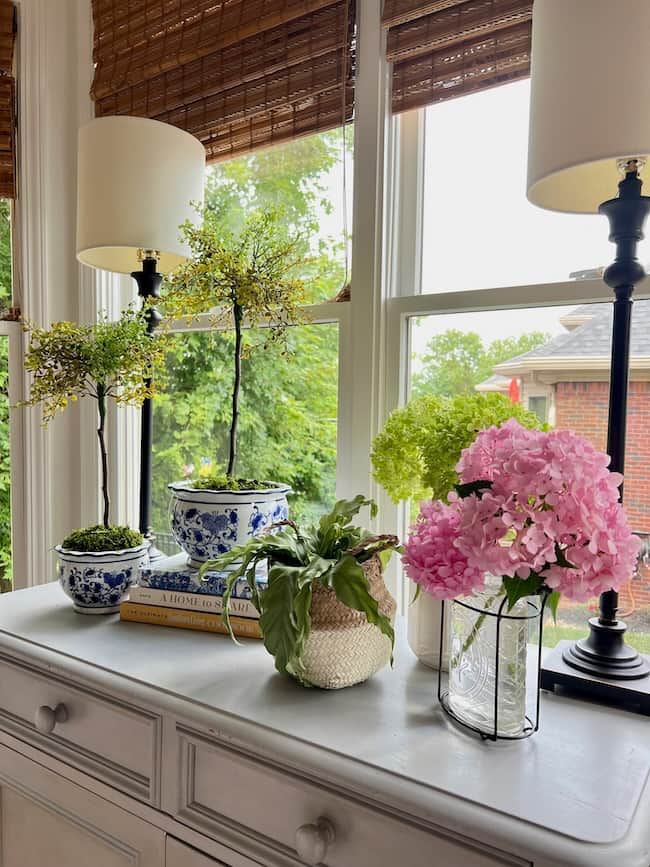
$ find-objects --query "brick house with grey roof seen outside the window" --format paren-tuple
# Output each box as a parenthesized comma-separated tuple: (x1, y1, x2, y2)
(478, 301, 650, 609)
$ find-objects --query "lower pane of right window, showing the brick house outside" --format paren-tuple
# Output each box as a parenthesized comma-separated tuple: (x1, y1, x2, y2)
(402, 288, 650, 653)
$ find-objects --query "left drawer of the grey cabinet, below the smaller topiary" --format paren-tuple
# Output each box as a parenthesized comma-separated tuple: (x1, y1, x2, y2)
(0, 658, 162, 806)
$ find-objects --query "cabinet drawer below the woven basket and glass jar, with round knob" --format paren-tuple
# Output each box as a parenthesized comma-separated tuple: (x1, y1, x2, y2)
(178, 728, 529, 867)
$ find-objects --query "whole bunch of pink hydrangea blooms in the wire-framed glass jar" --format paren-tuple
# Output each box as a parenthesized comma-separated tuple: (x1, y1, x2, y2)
(404, 419, 640, 601)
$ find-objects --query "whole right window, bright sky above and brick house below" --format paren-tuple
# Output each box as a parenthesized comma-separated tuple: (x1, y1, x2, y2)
(382, 61, 650, 652)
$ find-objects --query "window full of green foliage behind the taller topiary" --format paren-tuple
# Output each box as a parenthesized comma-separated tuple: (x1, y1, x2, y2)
(152, 130, 352, 552)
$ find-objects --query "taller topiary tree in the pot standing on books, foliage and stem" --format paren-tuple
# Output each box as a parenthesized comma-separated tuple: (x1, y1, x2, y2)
(161, 209, 306, 487)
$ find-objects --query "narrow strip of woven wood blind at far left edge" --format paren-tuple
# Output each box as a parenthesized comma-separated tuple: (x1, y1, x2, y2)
(0, 0, 16, 199)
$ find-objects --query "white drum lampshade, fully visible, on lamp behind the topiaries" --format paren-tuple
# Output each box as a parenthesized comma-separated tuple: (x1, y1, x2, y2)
(77, 116, 205, 274)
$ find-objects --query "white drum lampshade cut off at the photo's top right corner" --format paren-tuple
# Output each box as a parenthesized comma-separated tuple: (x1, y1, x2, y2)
(527, 0, 650, 213)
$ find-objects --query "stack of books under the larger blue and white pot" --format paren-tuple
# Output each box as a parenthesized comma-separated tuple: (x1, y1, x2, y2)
(120, 553, 266, 638)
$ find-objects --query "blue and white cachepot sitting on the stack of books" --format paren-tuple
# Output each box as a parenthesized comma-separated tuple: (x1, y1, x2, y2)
(168, 482, 291, 568)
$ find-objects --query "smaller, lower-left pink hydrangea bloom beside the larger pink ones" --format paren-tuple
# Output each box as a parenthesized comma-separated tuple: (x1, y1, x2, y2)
(402, 500, 484, 599)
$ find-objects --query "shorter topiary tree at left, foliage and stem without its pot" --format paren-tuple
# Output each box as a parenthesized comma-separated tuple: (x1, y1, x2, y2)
(23, 308, 165, 527)
